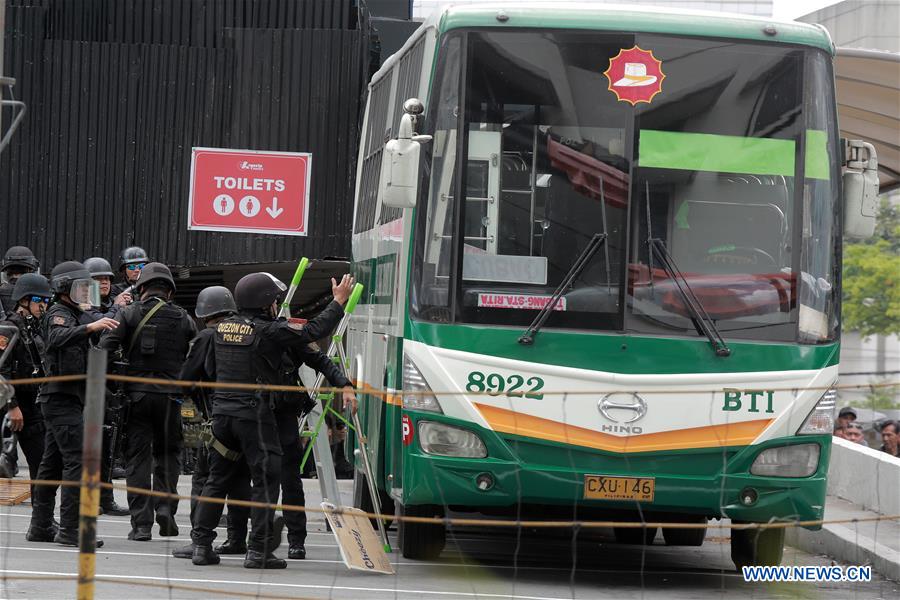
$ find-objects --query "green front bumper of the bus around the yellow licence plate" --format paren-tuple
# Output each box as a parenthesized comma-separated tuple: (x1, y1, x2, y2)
(402, 415, 831, 529)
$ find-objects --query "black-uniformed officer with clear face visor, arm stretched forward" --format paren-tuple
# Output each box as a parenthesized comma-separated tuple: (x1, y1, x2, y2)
(30, 261, 119, 548)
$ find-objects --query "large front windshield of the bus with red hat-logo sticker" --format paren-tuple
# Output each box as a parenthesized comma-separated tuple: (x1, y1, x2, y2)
(412, 30, 839, 343)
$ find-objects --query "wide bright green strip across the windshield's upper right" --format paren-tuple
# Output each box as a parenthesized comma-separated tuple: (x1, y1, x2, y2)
(638, 129, 794, 177)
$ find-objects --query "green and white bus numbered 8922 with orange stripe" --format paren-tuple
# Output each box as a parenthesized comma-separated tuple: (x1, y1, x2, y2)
(348, 2, 877, 566)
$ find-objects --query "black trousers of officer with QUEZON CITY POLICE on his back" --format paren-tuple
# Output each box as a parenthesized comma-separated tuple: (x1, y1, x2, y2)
(191, 414, 281, 552)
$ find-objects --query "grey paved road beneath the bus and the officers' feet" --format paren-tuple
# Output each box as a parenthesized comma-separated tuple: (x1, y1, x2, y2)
(0, 477, 900, 600)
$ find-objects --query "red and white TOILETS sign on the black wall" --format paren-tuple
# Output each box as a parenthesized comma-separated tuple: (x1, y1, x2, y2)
(188, 148, 312, 235)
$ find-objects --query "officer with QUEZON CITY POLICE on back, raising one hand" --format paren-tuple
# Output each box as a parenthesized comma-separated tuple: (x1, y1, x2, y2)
(191, 273, 353, 569)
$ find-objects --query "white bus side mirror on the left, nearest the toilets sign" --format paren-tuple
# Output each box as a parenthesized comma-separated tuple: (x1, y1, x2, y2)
(379, 98, 431, 208)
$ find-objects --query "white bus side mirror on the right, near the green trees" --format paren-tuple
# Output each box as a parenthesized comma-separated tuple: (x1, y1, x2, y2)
(842, 140, 878, 238)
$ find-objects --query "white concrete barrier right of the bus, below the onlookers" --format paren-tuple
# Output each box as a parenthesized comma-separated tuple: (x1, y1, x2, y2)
(826, 438, 900, 518)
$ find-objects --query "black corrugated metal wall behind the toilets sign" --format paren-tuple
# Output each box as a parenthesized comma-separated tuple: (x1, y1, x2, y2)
(0, 0, 369, 266)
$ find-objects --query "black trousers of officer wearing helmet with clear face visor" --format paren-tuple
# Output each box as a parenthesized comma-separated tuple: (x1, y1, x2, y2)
(31, 394, 84, 529)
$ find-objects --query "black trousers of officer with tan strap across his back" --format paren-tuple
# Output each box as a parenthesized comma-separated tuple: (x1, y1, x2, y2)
(125, 392, 183, 528)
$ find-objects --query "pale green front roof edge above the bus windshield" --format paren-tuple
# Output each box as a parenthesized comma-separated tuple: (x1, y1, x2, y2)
(423, 0, 834, 55)
